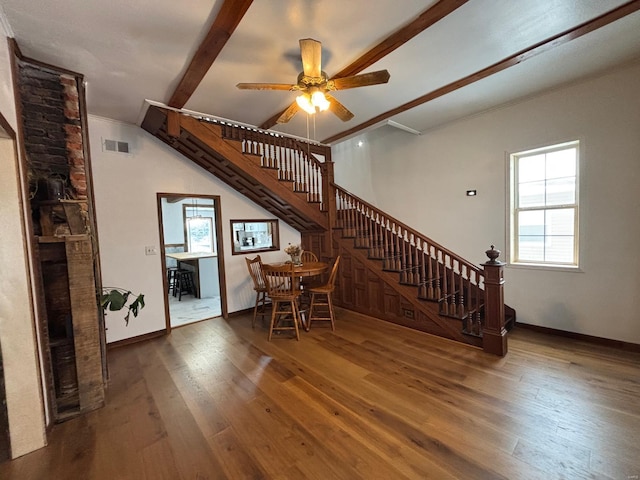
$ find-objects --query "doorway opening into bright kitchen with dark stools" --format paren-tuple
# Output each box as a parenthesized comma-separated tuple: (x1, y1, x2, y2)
(158, 193, 227, 331)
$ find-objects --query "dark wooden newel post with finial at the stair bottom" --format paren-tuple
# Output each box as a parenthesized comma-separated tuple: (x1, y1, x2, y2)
(481, 245, 507, 356)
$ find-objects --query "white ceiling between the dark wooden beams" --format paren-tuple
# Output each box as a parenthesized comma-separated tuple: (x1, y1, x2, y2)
(0, 0, 640, 144)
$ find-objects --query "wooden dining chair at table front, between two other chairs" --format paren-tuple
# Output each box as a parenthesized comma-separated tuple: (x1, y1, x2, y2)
(262, 263, 301, 341)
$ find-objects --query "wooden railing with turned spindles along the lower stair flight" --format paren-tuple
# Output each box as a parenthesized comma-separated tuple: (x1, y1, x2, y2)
(333, 184, 512, 353)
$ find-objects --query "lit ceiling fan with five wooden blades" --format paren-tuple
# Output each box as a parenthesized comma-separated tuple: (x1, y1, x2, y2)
(236, 38, 390, 123)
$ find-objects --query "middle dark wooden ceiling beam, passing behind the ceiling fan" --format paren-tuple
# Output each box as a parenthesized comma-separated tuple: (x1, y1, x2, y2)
(260, 0, 469, 130)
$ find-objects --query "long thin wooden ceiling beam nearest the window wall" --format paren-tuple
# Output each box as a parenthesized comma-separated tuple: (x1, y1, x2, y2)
(321, 0, 640, 144)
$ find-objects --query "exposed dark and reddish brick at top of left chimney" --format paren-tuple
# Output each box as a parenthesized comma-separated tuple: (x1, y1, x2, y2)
(18, 61, 87, 200)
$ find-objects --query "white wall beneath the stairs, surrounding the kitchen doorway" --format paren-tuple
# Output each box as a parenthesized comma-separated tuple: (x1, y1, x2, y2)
(89, 116, 300, 342)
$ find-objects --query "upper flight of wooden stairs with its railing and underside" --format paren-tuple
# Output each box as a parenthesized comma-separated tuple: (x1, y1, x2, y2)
(141, 106, 333, 232)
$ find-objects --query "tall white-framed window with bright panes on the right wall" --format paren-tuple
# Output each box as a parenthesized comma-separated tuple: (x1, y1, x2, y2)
(510, 141, 579, 267)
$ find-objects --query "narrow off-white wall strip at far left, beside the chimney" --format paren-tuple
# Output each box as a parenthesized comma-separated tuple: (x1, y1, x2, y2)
(0, 34, 46, 458)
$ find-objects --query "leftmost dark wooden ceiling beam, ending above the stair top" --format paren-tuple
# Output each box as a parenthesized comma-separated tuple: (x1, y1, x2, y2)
(168, 0, 253, 108)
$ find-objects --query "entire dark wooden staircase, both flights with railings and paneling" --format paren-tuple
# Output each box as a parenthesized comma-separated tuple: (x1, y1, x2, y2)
(142, 106, 516, 355)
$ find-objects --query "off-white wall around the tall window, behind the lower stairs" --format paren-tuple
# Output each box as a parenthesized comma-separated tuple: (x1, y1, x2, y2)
(333, 63, 640, 343)
